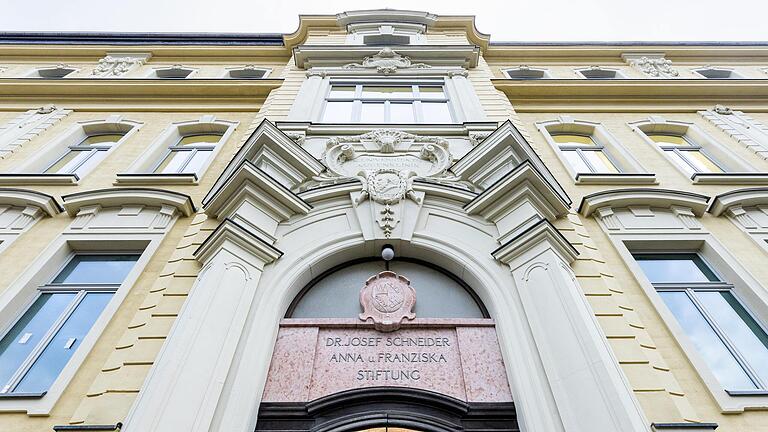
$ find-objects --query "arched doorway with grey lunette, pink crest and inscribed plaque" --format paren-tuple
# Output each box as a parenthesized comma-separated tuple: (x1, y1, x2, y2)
(256, 259, 518, 432)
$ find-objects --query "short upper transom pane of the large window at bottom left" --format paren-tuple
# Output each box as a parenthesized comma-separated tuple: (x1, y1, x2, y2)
(53, 254, 139, 284)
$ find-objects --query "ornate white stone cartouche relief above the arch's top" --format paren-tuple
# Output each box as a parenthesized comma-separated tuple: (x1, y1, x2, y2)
(308, 129, 459, 238)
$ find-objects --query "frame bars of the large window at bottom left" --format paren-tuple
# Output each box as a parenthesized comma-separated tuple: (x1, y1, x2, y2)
(0, 250, 142, 396)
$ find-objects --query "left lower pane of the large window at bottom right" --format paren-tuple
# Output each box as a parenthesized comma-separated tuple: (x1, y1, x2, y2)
(659, 291, 757, 390)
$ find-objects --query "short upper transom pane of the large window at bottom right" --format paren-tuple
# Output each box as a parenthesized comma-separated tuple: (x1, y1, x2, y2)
(635, 254, 720, 283)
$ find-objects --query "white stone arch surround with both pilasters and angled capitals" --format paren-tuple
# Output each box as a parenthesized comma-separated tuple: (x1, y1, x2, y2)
(124, 119, 648, 432)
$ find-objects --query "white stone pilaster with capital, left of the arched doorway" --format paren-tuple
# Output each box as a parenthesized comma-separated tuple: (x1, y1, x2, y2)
(124, 220, 280, 432)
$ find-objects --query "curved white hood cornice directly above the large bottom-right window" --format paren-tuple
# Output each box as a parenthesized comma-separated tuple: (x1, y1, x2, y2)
(578, 188, 709, 217)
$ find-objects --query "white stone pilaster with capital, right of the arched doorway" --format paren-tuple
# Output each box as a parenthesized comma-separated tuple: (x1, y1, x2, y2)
(493, 220, 649, 432)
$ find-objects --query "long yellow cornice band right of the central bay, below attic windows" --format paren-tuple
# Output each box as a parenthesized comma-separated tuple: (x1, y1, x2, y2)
(491, 78, 768, 112)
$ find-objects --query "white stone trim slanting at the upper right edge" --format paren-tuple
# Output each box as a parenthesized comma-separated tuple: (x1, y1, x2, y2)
(699, 105, 768, 159)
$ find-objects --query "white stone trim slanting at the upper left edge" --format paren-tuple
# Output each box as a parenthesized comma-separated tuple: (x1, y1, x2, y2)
(0, 105, 72, 159)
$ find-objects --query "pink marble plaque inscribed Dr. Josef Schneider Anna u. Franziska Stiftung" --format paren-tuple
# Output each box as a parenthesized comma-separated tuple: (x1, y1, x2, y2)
(263, 319, 512, 402)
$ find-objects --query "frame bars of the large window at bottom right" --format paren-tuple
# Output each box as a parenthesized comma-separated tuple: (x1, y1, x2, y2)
(632, 250, 768, 395)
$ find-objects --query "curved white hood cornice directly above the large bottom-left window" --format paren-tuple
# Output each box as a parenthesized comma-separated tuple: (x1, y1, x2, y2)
(61, 188, 196, 216)
